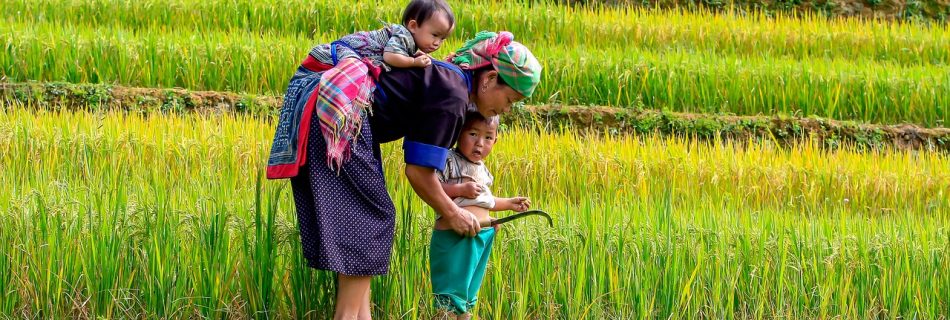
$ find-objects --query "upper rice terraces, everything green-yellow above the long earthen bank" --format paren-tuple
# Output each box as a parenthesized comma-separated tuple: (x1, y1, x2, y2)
(0, 0, 950, 127)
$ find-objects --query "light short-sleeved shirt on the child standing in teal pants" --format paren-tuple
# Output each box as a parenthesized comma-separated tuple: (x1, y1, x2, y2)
(439, 150, 495, 209)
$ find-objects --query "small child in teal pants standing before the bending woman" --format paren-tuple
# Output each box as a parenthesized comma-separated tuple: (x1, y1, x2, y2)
(429, 112, 531, 319)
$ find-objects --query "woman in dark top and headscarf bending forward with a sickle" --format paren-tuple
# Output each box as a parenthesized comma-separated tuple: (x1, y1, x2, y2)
(268, 33, 541, 319)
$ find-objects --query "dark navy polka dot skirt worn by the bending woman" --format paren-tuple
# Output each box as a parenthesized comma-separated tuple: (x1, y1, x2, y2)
(290, 112, 396, 275)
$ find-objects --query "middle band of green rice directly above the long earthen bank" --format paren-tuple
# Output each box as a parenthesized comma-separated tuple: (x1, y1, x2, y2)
(0, 18, 950, 126)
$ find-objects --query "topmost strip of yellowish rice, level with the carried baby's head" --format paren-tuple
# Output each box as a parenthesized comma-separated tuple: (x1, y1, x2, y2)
(0, 0, 950, 65)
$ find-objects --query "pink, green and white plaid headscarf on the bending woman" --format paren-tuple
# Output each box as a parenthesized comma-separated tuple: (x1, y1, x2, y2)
(452, 31, 541, 97)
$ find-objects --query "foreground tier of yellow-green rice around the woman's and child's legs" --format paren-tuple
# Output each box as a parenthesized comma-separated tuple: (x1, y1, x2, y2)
(0, 105, 950, 319)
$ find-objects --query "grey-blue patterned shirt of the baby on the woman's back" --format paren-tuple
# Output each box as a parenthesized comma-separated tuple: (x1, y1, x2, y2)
(310, 24, 418, 71)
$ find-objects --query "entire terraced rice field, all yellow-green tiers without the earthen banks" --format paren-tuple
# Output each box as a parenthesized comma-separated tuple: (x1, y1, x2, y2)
(0, 0, 950, 319)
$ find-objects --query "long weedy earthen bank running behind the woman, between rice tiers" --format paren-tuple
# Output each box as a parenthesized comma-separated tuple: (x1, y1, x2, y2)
(0, 82, 950, 152)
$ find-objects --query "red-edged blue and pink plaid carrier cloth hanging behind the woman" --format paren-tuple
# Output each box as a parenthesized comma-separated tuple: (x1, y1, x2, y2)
(267, 41, 380, 179)
